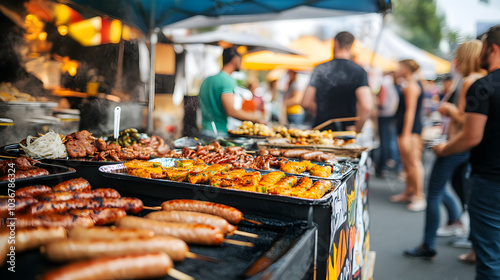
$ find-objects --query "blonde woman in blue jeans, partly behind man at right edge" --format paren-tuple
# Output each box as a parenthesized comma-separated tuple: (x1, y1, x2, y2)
(404, 40, 485, 258)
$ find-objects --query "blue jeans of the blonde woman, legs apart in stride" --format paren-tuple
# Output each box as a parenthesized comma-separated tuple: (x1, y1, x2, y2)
(424, 152, 469, 249)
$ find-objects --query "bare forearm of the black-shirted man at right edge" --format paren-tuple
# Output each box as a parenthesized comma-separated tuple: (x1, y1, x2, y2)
(434, 113, 488, 157)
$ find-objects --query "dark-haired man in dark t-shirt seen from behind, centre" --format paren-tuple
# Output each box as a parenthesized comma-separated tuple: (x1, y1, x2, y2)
(302, 31, 372, 132)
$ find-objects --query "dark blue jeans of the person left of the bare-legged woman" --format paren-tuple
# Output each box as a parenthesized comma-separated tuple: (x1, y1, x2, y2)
(377, 117, 403, 172)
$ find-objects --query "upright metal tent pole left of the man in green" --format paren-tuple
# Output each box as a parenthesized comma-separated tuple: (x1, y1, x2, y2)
(148, 0, 159, 133)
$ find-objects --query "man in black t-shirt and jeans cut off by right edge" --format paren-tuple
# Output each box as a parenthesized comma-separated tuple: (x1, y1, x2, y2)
(434, 25, 500, 279)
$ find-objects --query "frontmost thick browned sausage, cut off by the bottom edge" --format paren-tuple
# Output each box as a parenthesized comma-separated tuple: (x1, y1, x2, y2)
(42, 253, 174, 280)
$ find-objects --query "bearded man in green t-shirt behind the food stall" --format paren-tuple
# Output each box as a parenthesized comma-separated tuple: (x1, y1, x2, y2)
(198, 48, 263, 136)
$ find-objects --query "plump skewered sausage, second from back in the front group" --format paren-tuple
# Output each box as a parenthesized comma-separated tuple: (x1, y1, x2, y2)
(146, 211, 236, 234)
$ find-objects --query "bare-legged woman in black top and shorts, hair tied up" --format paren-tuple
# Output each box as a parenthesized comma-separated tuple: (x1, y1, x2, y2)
(391, 59, 427, 212)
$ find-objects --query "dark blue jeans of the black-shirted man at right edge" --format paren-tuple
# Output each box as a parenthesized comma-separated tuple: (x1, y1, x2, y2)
(469, 175, 500, 280)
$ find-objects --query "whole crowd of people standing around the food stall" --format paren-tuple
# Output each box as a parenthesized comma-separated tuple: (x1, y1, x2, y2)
(199, 26, 500, 279)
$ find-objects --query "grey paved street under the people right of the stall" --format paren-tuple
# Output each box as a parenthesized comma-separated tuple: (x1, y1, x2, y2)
(369, 151, 475, 280)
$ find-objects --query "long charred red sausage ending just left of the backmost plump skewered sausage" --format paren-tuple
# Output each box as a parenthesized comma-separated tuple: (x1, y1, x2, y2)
(26, 197, 144, 215)
